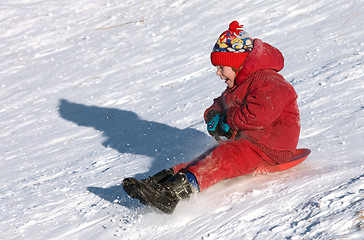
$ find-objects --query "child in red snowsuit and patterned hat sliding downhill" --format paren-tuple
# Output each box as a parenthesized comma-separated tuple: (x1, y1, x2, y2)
(123, 21, 300, 213)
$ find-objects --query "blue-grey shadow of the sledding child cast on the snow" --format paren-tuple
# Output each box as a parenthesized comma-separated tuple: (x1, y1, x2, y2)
(59, 99, 213, 208)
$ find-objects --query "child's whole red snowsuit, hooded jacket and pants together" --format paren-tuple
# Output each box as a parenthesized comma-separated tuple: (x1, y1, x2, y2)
(173, 39, 300, 190)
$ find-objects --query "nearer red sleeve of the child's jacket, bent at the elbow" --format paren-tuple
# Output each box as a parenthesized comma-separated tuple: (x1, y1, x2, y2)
(227, 79, 289, 130)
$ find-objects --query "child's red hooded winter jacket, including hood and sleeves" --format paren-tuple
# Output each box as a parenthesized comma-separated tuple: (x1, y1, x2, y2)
(205, 39, 300, 163)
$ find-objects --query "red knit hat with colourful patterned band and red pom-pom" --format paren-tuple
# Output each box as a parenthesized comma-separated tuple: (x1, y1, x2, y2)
(211, 21, 253, 69)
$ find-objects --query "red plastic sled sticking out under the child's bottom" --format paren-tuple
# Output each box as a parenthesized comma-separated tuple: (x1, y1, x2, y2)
(254, 148, 311, 174)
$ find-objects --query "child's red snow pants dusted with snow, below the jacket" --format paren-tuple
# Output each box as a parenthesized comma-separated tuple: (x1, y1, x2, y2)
(173, 139, 275, 191)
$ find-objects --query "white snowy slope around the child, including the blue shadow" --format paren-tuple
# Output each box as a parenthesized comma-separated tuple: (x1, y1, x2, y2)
(0, 0, 364, 239)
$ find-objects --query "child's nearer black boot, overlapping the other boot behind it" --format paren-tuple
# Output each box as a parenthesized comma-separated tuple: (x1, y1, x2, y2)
(123, 172, 194, 214)
